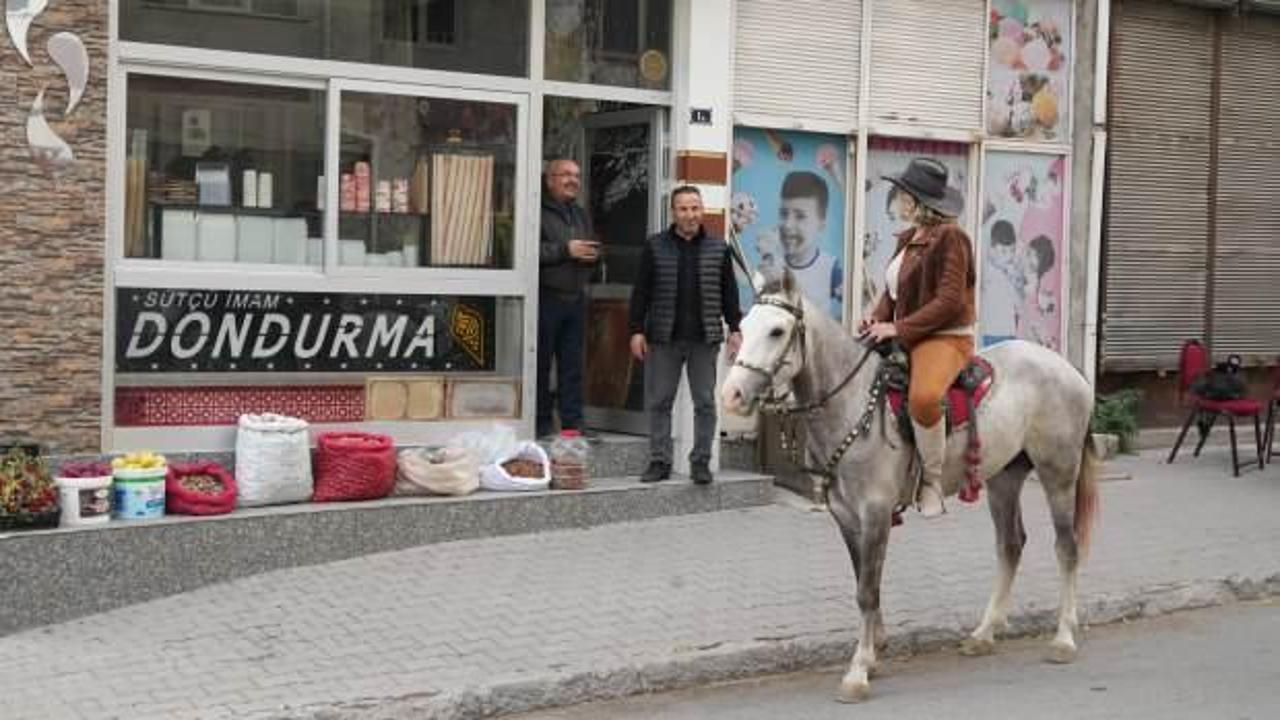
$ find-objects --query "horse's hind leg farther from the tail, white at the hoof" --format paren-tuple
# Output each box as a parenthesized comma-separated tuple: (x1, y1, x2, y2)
(960, 457, 1030, 656)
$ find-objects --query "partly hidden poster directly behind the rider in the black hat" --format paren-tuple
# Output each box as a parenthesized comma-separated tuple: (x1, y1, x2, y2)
(861, 137, 969, 314)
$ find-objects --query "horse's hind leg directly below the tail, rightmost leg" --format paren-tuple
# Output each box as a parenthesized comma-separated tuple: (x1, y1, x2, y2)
(1036, 461, 1080, 662)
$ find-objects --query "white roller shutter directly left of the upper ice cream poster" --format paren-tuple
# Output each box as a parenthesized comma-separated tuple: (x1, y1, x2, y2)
(869, 0, 987, 131)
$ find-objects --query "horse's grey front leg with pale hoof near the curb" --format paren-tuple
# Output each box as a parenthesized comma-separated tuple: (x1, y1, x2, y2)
(837, 505, 893, 702)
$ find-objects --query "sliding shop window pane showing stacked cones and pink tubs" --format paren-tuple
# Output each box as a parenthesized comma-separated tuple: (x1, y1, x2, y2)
(338, 92, 517, 269)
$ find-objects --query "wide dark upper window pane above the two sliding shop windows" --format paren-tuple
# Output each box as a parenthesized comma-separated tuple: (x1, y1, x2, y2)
(120, 0, 529, 76)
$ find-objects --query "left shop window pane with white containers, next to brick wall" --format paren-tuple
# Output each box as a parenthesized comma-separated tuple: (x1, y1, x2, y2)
(124, 74, 324, 265)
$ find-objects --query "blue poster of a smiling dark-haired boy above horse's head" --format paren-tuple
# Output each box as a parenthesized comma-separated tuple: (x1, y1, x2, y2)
(728, 128, 849, 320)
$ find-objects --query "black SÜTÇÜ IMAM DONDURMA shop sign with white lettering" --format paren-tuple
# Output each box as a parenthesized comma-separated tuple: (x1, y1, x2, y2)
(115, 287, 495, 373)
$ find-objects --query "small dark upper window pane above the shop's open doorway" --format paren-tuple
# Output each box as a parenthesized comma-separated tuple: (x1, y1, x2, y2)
(547, 0, 672, 90)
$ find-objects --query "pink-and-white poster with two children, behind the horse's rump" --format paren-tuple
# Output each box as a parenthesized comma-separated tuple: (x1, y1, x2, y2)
(978, 152, 1066, 351)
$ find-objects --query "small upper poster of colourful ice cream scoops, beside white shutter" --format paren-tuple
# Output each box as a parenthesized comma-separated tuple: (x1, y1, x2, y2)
(987, 0, 1073, 142)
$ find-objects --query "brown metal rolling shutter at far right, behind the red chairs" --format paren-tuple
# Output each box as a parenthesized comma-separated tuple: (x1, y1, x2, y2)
(1212, 14, 1280, 363)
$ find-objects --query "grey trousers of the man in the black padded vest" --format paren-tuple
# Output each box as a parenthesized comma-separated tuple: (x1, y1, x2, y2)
(644, 342, 719, 465)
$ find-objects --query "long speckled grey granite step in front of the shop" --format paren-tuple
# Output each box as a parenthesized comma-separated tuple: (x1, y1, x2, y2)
(0, 468, 773, 635)
